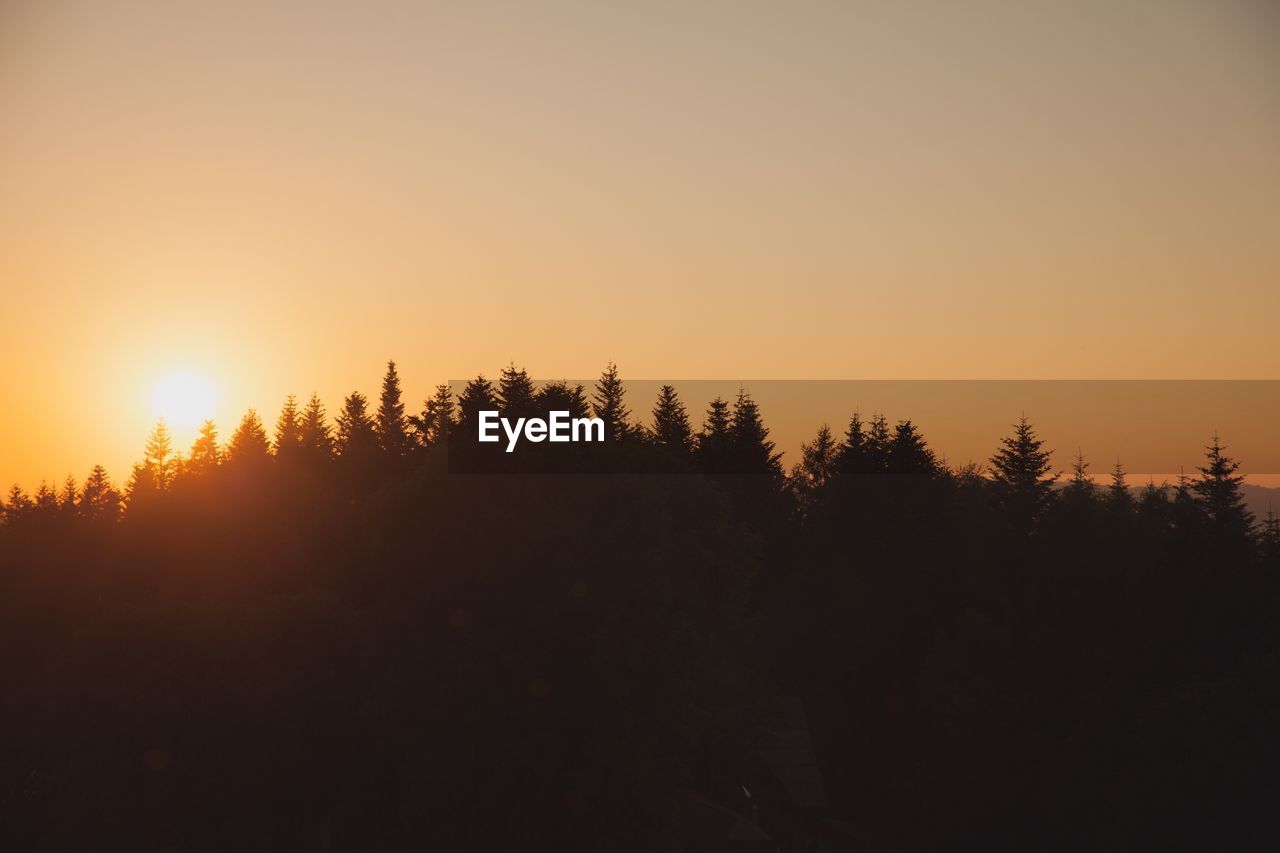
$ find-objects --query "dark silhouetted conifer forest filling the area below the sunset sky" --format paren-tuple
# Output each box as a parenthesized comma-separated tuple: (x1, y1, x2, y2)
(0, 362, 1280, 850)
